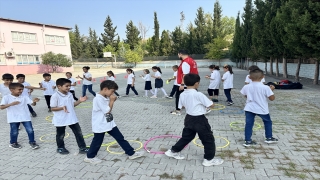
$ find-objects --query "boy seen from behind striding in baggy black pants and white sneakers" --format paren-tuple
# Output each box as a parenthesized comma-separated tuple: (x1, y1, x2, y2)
(165, 74, 223, 166)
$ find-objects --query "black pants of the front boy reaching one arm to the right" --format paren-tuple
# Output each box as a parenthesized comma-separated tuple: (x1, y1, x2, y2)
(56, 123, 86, 148)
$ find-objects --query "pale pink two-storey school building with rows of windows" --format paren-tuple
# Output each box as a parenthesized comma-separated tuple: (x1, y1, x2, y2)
(0, 18, 73, 75)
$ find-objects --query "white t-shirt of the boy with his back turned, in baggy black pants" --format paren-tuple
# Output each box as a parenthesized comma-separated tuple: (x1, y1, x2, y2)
(178, 89, 213, 116)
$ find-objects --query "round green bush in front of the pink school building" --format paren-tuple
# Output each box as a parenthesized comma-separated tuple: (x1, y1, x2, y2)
(41, 51, 72, 73)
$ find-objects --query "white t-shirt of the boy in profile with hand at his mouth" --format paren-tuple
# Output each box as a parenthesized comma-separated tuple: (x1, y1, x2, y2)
(92, 94, 117, 133)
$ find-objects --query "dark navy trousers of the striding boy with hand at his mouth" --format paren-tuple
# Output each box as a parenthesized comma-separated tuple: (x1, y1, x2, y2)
(87, 126, 135, 158)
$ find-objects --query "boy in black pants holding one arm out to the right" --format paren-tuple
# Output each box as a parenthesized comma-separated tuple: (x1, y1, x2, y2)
(50, 78, 88, 154)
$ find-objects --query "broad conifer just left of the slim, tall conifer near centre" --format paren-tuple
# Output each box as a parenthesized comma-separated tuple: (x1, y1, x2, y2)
(125, 20, 141, 50)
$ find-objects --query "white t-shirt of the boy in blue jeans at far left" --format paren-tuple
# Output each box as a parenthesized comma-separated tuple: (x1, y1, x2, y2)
(1, 94, 32, 123)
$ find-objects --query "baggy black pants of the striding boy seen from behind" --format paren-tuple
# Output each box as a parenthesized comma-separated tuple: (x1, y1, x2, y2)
(171, 114, 216, 160)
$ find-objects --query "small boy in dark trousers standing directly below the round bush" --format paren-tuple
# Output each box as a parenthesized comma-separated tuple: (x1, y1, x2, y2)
(39, 73, 56, 112)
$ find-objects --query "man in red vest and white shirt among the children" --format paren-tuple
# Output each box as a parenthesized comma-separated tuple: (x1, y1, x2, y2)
(171, 50, 199, 115)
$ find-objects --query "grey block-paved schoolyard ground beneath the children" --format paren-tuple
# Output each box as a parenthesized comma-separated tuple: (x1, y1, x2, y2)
(0, 69, 320, 180)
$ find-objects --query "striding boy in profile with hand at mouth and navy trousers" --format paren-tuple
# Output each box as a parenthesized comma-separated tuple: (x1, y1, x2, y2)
(84, 80, 143, 164)
